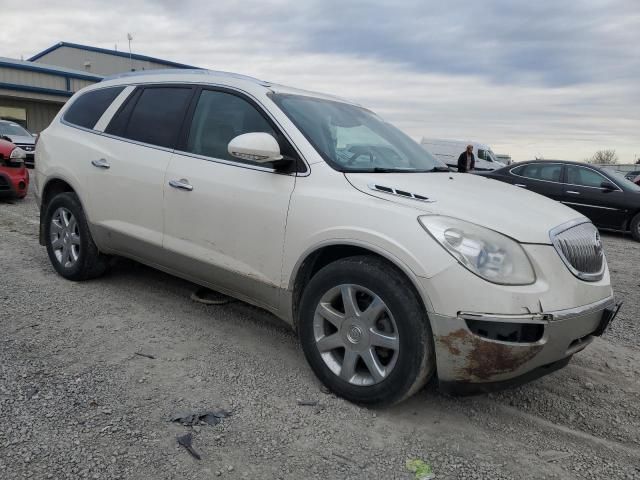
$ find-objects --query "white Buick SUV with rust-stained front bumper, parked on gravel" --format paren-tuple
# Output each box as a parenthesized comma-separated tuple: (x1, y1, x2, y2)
(36, 70, 616, 404)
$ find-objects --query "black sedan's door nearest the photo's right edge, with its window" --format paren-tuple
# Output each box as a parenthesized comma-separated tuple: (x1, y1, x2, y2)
(562, 165, 627, 229)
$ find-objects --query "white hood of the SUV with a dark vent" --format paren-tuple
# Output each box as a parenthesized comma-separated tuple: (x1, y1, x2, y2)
(345, 172, 582, 244)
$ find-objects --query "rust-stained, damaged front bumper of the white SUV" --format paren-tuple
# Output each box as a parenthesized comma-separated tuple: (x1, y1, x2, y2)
(430, 296, 619, 393)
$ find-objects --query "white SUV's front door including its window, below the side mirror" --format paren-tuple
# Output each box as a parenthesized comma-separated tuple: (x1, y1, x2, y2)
(164, 89, 296, 307)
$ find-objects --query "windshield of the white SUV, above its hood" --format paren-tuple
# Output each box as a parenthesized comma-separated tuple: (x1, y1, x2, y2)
(271, 94, 449, 172)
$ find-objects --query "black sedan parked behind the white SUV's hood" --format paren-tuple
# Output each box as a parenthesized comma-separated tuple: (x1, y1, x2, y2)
(480, 160, 640, 241)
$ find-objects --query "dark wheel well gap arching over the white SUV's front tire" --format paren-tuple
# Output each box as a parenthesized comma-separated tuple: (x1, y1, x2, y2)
(292, 245, 424, 330)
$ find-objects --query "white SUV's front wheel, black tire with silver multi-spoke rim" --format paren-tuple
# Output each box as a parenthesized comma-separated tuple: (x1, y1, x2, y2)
(298, 256, 435, 405)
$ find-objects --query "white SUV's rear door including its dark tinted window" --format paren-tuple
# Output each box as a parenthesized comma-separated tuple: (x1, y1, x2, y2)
(87, 85, 193, 261)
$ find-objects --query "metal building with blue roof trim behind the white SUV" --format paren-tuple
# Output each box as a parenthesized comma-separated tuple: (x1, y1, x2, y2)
(0, 42, 196, 133)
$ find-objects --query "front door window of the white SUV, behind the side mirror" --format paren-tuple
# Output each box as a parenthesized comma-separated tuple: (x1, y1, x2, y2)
(186, 90, 276, 164)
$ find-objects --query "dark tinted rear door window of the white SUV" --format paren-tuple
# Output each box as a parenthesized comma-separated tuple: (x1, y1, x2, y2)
(107, 87, 192, 148)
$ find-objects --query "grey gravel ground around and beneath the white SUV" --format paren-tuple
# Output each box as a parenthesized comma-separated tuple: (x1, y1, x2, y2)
(0, 188, 640, 479)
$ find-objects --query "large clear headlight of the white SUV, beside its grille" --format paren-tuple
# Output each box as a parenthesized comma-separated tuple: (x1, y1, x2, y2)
(418, 215, 536, 285)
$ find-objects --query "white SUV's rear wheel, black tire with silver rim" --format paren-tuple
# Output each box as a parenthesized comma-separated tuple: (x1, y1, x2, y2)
(43, 192, 108, 281)
